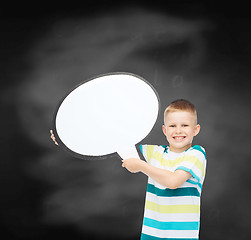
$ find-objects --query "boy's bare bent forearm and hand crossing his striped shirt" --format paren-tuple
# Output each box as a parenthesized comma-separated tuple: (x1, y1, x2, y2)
(122, 158, 192, 189)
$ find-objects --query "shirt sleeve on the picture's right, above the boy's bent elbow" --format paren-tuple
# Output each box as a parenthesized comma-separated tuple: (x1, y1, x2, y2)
(176, 145, 206, 184)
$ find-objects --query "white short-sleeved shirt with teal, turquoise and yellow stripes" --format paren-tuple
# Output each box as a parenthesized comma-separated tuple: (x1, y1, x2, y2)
(140, 145, 206, 240)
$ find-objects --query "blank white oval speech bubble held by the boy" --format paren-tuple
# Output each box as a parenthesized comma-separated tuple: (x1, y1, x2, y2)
(54, 73, 159, 159)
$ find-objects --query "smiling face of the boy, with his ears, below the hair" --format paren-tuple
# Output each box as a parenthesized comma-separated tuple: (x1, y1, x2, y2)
(162, 111, 200, 152)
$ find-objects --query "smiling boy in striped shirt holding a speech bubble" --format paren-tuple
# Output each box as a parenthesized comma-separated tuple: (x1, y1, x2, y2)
(122, 99, 206, 240)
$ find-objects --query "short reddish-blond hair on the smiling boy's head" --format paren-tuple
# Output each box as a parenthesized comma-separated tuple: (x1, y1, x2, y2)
(164, 99, 197, 122)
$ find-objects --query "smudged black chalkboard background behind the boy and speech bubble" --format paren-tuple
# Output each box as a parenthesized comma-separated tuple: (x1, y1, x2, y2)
(0, 1, 251, 240)
